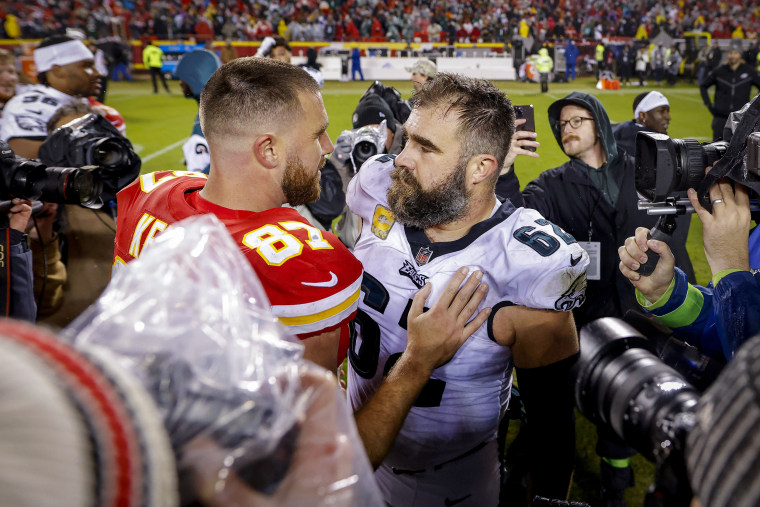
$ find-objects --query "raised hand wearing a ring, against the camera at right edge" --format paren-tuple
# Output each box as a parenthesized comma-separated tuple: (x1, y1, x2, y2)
(689, 178, 750, 276)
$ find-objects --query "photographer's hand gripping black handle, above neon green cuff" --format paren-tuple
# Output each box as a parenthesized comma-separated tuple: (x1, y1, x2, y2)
(618, 227, 676, 303)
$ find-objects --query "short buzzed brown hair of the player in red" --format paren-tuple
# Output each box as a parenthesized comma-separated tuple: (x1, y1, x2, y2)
(199, 57, 319, 138)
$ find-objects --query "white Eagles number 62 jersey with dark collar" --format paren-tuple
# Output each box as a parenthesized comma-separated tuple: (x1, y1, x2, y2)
(347, 155, 589, 470)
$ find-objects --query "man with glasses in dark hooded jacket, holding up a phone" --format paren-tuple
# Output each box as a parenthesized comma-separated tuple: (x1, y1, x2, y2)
(523, 92, 691, 505)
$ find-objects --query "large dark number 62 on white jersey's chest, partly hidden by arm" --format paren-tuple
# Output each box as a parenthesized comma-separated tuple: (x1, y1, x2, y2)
(348, 271, 446, 407)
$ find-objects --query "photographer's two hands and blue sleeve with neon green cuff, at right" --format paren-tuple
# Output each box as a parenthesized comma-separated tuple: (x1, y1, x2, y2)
(618, 179, 760, 360)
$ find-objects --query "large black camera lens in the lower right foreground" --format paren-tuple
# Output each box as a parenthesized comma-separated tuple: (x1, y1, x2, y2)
(574, 316, 722, 506)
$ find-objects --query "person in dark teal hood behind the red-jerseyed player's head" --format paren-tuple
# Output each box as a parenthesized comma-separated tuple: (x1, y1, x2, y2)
(174, 49, 222, 174)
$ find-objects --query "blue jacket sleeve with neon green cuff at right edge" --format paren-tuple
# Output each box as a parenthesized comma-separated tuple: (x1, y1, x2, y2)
(637, 227, 760, 360)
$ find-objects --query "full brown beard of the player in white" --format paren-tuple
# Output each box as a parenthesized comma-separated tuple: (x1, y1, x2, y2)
(387, 161, 470, 230)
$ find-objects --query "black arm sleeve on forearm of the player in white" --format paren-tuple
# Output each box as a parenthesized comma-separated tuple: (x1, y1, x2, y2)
(515, 354, 579, 500)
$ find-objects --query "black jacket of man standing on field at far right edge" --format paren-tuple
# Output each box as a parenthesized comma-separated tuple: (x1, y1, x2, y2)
(699, 63, 760, 118)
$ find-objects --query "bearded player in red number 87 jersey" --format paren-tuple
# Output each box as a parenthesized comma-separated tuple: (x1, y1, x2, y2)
(114, 58, 362, 371)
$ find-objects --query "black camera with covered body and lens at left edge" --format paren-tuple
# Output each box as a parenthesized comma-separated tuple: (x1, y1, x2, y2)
(0, 114, 141, 209)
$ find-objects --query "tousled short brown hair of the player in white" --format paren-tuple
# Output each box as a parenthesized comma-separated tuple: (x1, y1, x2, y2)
(412, 72, 515, 177)
